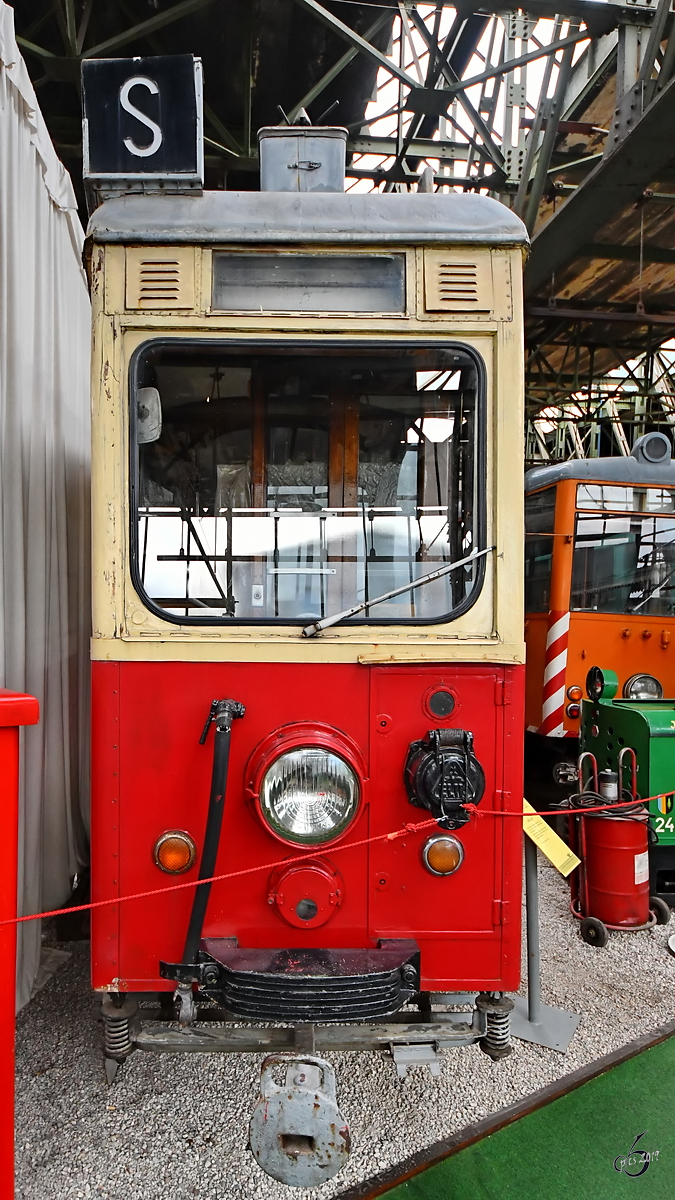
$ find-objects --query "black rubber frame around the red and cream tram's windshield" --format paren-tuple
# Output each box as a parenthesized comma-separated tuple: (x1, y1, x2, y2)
(126, 334, 488, 631)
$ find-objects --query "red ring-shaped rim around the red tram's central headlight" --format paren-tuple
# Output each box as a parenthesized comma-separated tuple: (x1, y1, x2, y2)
(246, 721, 368, 852)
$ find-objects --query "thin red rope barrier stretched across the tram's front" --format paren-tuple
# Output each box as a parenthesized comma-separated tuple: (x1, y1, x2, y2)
(5, 792, 664, 928)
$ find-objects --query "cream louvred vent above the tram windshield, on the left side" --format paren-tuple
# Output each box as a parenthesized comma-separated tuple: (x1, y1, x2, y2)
(126, 246, 195, 310)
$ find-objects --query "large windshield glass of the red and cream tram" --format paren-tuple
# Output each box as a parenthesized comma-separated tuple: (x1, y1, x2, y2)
(131, 342, 483, 624)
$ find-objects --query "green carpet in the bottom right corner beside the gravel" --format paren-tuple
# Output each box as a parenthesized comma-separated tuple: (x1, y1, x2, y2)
(387, 1037, 675, 1200)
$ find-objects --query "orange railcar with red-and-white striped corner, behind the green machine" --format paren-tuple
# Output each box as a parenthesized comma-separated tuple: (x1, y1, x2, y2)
(525, 432, 675, 806)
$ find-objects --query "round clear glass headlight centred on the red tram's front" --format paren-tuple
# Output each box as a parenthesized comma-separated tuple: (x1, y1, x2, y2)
(259, 746, 359, 846)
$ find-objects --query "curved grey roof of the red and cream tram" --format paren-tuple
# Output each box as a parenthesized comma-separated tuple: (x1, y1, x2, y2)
(88, 192, 528, 246)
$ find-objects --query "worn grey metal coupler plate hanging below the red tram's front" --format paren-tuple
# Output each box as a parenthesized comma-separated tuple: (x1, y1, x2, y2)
(250, 1055, 351, 1188)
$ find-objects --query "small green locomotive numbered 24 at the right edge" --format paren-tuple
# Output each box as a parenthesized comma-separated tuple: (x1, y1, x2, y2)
(581, 667, 675, 907)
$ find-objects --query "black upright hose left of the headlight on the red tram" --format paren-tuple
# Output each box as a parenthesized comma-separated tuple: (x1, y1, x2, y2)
(183, 700, 245, 962)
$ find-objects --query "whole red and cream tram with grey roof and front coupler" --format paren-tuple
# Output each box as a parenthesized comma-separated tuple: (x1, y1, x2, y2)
(88, 117, 526, 1186)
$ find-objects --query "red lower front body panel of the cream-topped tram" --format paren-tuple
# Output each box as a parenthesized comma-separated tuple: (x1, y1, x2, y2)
(91, 662, 524, 991)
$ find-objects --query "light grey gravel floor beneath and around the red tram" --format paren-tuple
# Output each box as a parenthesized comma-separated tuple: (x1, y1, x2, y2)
(16, 859, 675, 1200)
